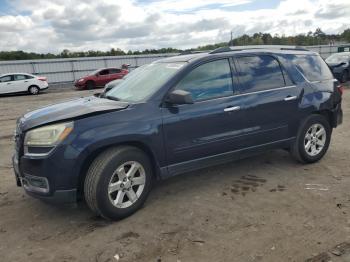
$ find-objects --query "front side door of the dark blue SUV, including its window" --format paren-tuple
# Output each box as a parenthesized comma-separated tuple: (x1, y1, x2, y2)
(162, 59, 244, 175)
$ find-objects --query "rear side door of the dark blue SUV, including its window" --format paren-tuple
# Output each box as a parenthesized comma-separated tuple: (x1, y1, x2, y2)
(234, 55, 302, 146)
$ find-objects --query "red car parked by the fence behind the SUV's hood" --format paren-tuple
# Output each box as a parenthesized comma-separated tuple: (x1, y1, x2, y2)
(74, 66, 129, 89)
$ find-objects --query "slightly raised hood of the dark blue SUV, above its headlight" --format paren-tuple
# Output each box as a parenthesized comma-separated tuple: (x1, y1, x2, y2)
(18, 96, 129, 131)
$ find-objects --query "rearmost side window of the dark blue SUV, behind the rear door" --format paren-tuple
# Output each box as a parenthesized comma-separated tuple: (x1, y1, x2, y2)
(292, 55, 333, 81)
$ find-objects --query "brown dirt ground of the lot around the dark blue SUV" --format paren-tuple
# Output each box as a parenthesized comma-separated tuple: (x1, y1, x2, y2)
(0, 85, 350, 262)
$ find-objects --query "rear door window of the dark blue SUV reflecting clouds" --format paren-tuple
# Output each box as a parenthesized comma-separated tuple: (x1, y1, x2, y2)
(236, 55, 285, 93)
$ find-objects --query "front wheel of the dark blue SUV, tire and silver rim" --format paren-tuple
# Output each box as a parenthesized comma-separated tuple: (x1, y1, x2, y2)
(84, 146, 153, 220)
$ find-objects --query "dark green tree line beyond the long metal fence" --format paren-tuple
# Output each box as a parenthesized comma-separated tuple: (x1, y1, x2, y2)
(0, 28, 350, 60)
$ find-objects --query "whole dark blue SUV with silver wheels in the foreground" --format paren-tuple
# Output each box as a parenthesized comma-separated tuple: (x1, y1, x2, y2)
(13, 46, 343, 219)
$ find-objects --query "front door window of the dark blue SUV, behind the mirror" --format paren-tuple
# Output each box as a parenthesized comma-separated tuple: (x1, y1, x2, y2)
(175, 59, 233, 101)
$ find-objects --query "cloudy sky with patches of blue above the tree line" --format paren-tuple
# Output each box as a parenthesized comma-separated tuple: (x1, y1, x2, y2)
(0, 0, 350, 53)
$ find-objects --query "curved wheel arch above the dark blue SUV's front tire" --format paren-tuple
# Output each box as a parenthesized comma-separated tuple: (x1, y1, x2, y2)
(77, 141, 160, 198)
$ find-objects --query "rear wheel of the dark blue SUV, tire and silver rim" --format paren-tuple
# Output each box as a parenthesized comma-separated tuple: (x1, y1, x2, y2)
(291, 115, 332, 163)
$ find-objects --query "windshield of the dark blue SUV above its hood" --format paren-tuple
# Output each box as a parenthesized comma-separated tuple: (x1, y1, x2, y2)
(106, 62, 185, 102)
